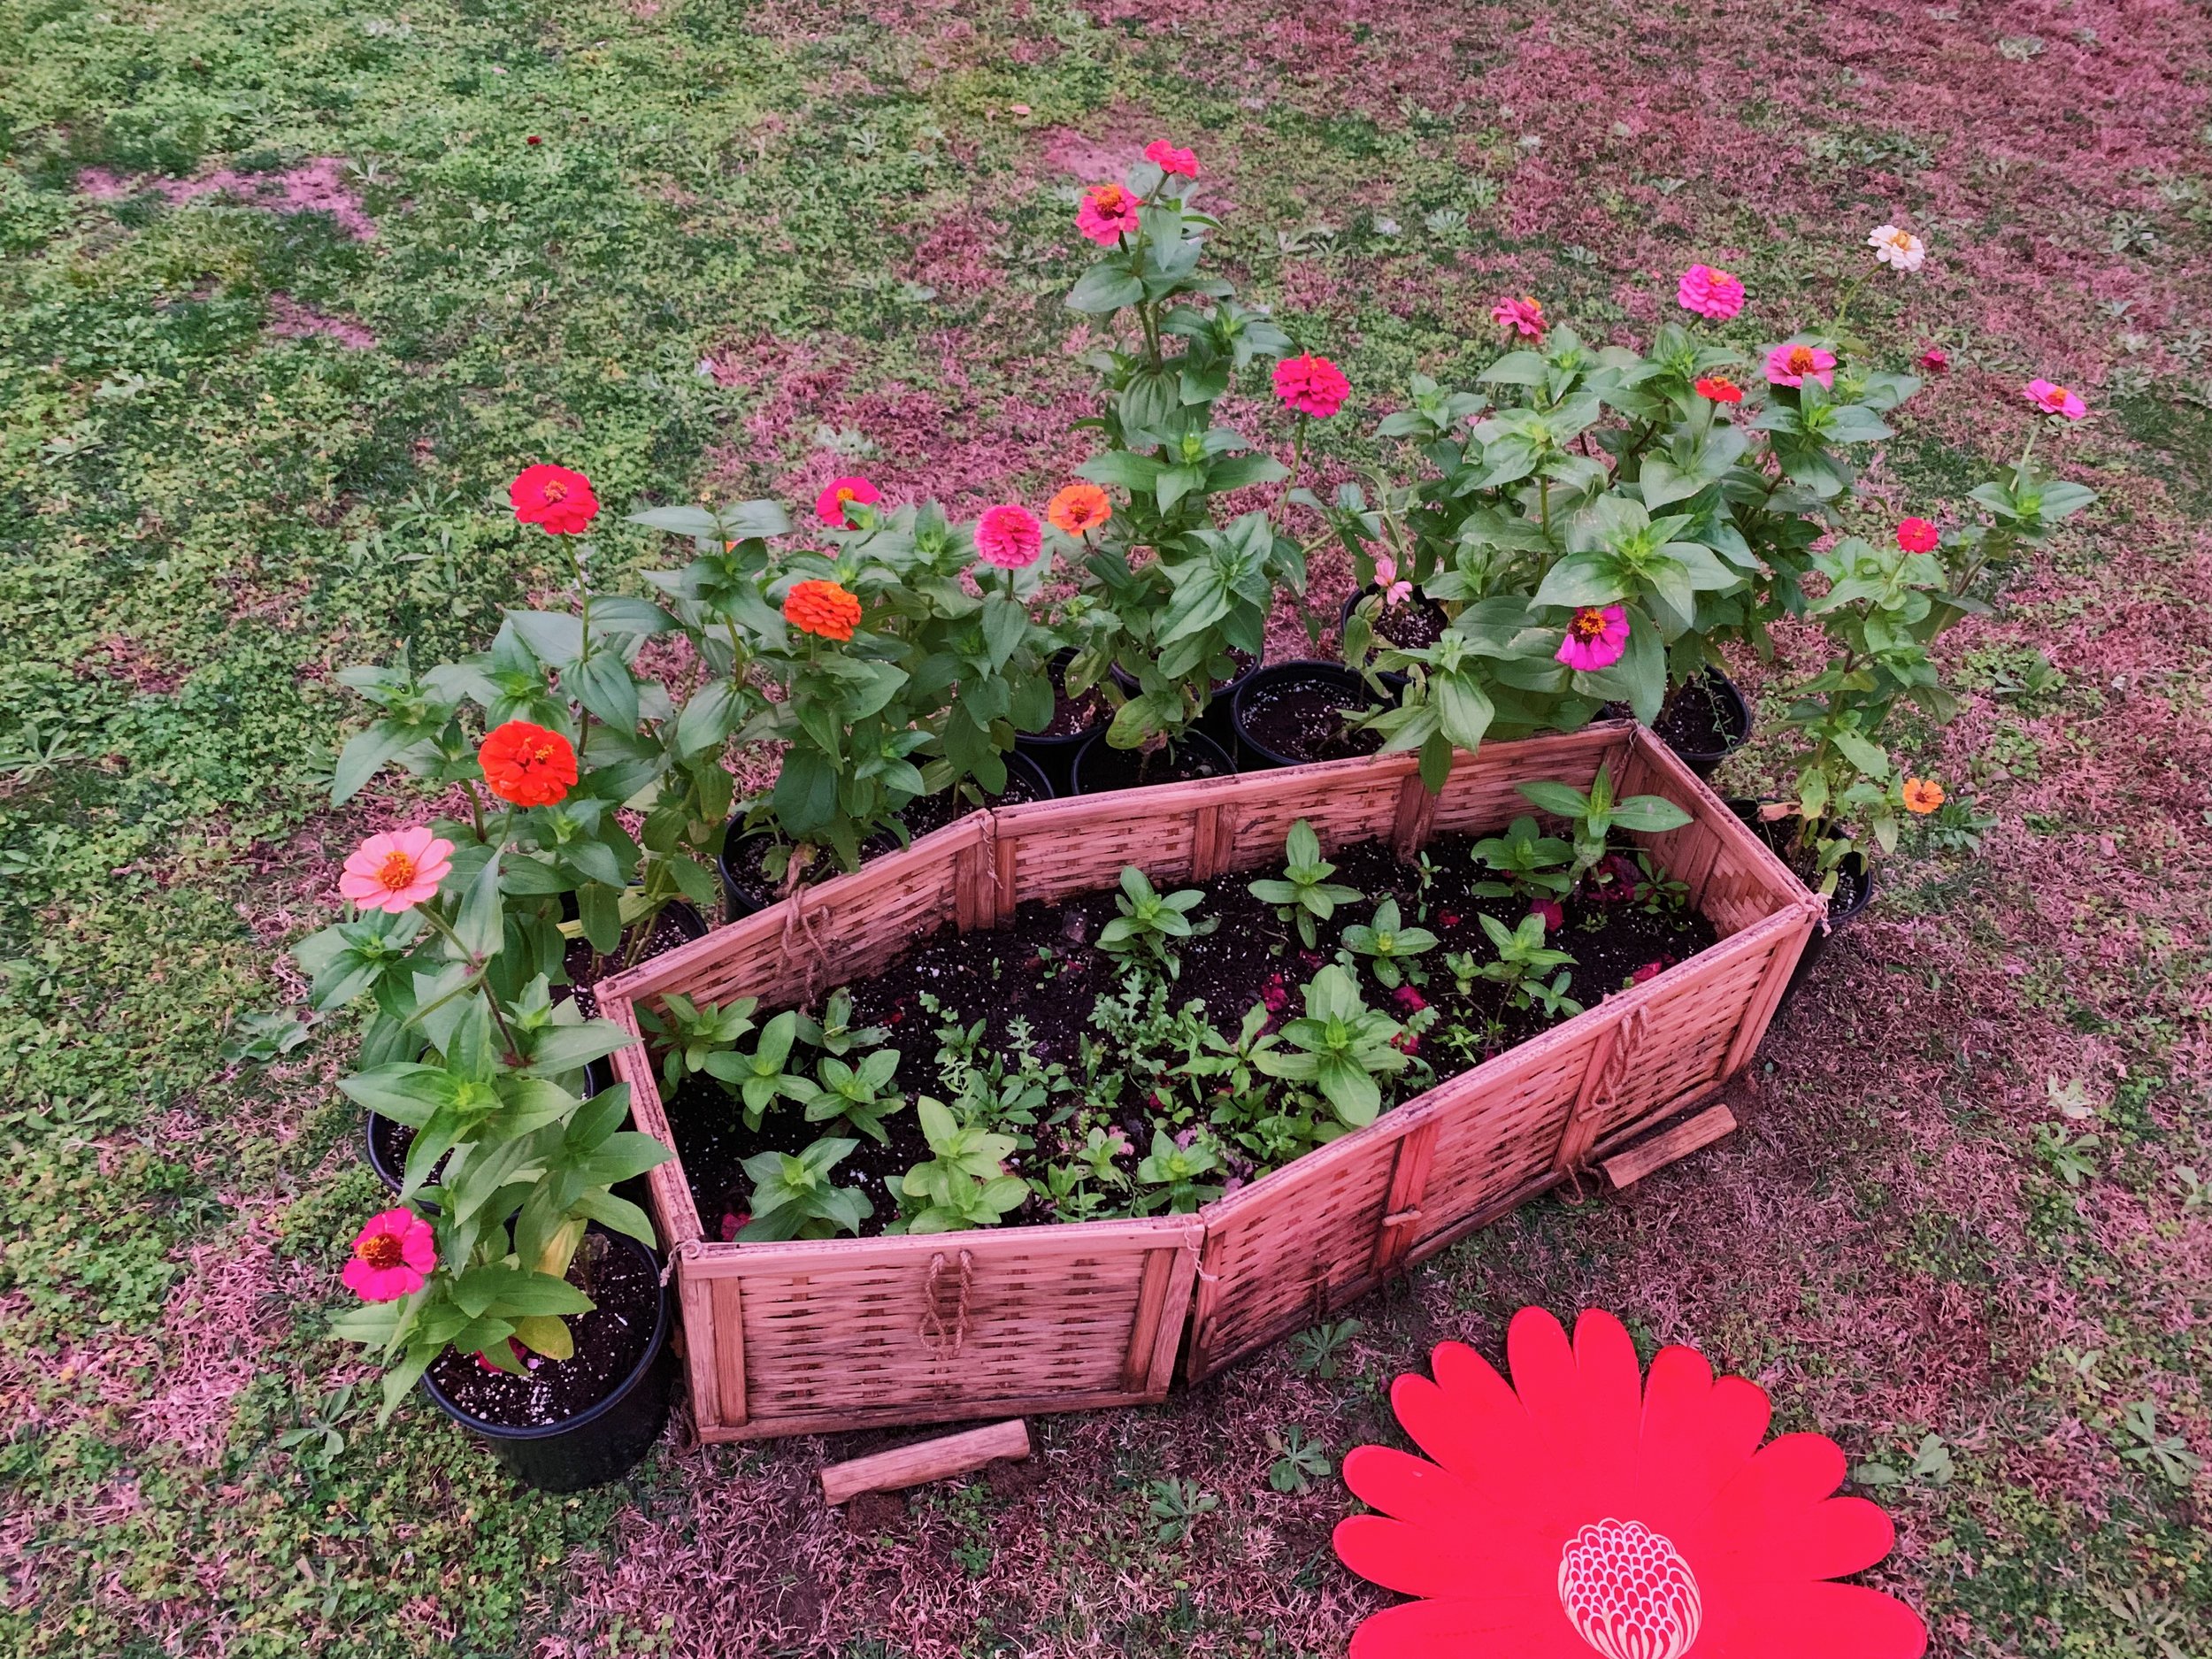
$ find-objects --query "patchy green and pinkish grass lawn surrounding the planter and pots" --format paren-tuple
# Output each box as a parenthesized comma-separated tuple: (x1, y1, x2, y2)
(0, 0, 2212, 1659)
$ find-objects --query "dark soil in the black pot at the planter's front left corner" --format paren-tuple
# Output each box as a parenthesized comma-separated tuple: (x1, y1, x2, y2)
(416, 1234, 662, 1429)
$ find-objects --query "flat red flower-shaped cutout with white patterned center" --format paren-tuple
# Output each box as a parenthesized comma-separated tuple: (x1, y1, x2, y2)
(1336, 1308, 1927, 1659)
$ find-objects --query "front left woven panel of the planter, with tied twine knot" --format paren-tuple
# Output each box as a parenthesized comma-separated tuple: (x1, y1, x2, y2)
(684, 1217, 1202, 1440)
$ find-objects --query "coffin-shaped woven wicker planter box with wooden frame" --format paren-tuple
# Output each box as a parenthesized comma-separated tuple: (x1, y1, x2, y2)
(600, 724, 1825, 1440)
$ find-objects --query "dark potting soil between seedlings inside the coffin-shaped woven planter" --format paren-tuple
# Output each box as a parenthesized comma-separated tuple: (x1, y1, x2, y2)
(666, 836, 1715, 1239)
